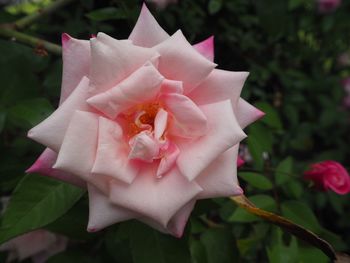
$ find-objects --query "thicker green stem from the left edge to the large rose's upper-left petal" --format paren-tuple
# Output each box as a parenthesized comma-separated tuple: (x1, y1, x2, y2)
(0, 26, 62, 56)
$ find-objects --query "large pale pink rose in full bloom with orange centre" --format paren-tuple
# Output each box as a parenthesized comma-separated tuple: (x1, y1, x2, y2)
(28, 5, 263, 237)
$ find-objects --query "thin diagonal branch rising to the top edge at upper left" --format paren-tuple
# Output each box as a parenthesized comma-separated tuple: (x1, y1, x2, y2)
(13, 0, 74, 30)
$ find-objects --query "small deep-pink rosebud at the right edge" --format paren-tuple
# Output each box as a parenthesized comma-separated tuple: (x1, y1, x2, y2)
(304, 161, 350, 195)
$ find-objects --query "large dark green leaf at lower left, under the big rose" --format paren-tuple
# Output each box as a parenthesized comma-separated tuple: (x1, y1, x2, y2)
(0, 174, 85, 243)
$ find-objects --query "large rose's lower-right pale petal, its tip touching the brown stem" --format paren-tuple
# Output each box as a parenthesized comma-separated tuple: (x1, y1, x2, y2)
(196, 144, 243, 199)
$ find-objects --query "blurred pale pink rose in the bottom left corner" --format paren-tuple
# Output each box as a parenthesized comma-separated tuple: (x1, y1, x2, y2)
(0, 229, 67, 263)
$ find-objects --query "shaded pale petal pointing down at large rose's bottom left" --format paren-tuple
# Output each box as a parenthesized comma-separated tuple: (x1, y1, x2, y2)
(87, 184, 136, 232)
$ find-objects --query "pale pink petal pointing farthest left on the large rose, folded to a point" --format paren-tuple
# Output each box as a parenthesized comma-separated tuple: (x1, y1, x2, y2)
(28, 77, 93, 152)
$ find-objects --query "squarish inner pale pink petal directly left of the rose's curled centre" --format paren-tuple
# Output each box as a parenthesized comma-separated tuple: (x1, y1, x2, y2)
(92, 117, 139, 184)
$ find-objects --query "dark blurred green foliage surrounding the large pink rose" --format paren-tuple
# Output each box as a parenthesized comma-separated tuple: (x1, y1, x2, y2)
(0, 0, 350, 263)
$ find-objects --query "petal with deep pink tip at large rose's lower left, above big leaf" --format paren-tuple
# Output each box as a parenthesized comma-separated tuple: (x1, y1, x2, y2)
(26, 148, 86, 188)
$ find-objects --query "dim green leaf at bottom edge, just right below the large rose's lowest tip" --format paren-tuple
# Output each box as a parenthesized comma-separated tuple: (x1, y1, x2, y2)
(200, 228, 238, 263)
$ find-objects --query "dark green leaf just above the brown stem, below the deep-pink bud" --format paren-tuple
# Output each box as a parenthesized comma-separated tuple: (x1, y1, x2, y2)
(281, 201, 321, 233)
